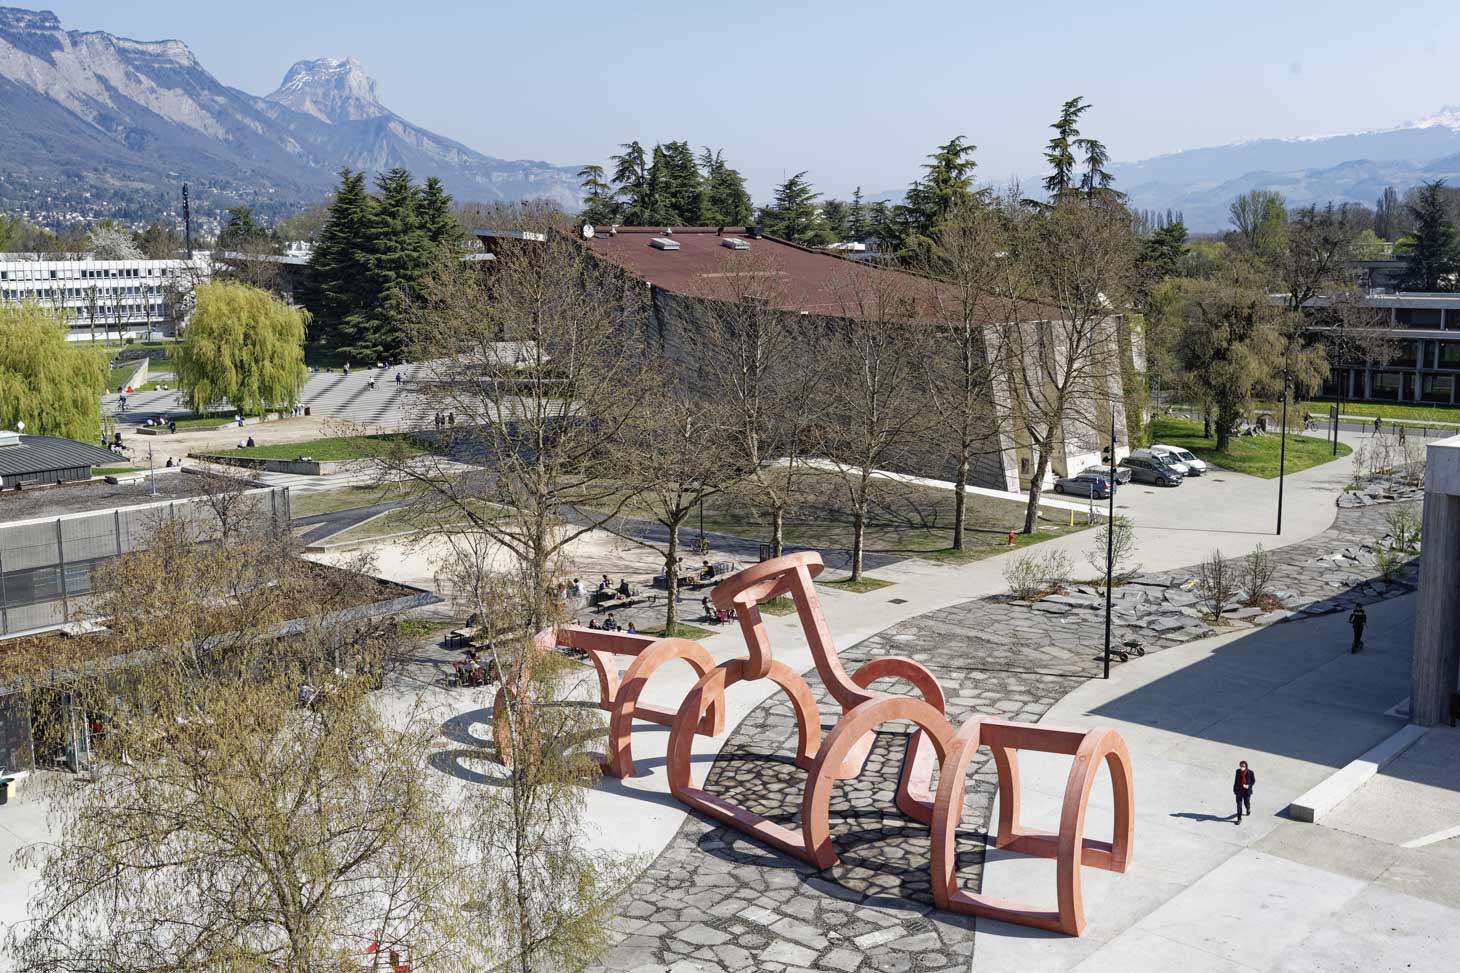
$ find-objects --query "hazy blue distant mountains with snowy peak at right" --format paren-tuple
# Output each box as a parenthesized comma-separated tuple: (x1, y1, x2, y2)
(1111, 105, 1460, 231)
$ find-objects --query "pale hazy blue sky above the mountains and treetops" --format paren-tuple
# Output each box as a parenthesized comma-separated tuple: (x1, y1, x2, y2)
(39, 0, 1460, 197)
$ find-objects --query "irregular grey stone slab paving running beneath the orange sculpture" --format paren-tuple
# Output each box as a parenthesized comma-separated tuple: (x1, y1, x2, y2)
(599, 505, 1418, 973)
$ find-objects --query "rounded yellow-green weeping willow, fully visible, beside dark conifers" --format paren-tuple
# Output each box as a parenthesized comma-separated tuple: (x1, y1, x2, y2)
(175, 281, 308, 413)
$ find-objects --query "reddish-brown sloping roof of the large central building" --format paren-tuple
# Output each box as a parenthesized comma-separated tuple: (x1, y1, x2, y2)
(574, 226, 1027, 323)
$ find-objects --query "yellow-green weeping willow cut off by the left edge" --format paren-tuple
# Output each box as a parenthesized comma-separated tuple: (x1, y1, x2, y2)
(0, 301, 107, 440)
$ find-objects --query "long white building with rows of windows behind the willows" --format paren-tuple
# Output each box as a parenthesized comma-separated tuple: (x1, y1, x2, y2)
(0, 254, 212, 340)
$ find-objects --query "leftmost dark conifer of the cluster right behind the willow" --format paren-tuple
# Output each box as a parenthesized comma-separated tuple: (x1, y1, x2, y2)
(299, 168, 375, 351)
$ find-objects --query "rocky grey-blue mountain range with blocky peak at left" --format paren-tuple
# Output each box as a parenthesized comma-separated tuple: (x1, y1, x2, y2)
(0, 7, 580, 224)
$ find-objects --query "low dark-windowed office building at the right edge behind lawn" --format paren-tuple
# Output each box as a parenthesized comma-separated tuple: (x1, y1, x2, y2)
(1310, 292, 1460, 405)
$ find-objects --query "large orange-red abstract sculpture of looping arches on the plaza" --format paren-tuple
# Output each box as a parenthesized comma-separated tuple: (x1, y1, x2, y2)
(496, 552, 1134, 936)
